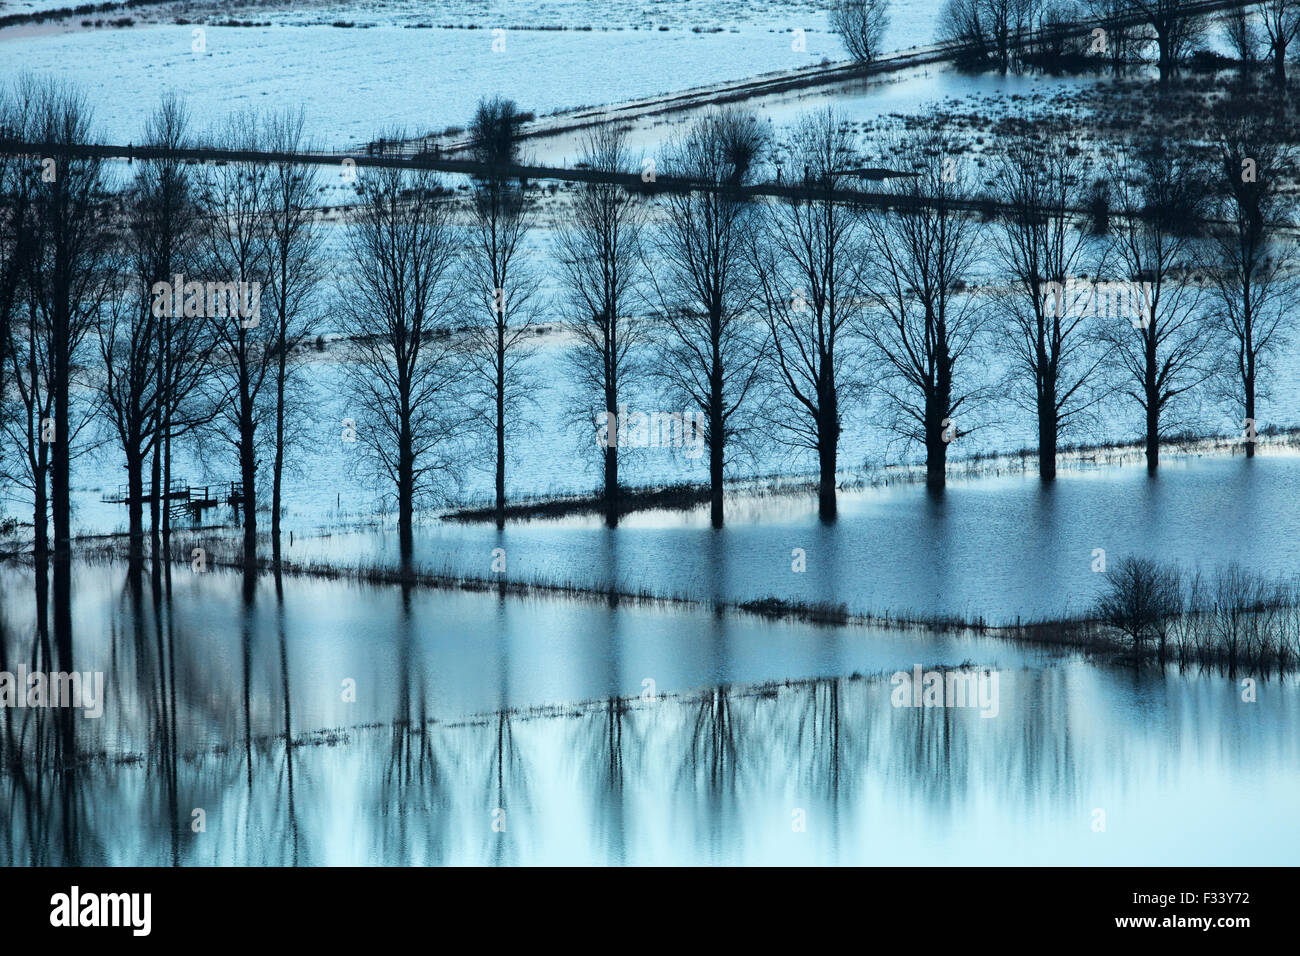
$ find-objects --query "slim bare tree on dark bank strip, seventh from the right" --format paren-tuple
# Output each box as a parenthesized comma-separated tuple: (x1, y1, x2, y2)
(555, 125, 646, 528)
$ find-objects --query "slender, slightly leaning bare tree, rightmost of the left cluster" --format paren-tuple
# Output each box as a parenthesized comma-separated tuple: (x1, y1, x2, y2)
(257, 109, 325, 561)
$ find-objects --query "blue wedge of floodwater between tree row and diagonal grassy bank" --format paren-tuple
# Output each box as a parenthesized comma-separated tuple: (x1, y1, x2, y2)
(287, 454, 1300, 623)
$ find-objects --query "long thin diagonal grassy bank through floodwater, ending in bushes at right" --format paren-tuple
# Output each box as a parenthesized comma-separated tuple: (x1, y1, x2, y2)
(45, 538, 1284, 672)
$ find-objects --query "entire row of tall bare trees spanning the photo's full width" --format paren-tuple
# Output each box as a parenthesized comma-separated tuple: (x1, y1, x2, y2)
(0, 83, 1295, 561)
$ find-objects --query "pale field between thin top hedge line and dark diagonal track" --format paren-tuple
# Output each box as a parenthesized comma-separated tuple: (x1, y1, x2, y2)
(0, 26, 837, 147)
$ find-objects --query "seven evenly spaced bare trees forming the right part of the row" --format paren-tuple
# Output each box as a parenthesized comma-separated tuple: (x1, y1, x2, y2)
(562, 105, 1295, 523)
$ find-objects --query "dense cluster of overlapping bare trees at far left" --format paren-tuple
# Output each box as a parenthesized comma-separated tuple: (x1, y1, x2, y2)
(0, 78, 322, 559)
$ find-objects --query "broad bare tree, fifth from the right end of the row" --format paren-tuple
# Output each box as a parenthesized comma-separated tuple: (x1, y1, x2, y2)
(750, 109, 862, 522)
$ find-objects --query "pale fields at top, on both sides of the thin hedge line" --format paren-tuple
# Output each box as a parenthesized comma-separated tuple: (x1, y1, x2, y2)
(0, 0, 937, 147)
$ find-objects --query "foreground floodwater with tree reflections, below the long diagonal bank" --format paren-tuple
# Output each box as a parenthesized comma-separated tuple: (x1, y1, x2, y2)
(0, 564, 1300, 865)
